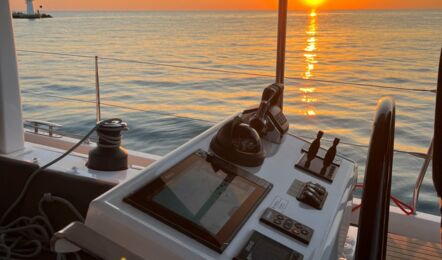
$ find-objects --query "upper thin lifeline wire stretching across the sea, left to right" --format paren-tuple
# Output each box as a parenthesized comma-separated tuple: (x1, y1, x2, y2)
(17, 50, 436, 93)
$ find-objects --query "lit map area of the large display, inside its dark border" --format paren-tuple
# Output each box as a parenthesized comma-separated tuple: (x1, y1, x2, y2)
(153, 157, 255, 234)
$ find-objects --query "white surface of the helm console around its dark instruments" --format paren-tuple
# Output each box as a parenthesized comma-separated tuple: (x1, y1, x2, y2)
(86, 118, 357, 259)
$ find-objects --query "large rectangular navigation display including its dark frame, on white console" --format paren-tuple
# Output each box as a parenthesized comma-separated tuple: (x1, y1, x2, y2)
(125, 151, 271, 252)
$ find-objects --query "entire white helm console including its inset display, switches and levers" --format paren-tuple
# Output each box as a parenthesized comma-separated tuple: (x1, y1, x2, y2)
(86, 118, 357, 260)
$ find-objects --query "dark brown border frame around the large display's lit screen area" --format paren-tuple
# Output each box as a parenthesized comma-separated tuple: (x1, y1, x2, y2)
(123, 151, 272, 253)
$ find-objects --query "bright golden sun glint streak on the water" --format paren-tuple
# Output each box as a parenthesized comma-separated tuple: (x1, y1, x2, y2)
(299, 10, 318, 117)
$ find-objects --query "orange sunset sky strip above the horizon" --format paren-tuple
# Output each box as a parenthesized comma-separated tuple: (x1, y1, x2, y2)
(9, 0, 442, 10)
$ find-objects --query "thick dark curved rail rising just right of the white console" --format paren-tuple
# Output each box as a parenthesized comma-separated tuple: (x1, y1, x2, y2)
(355, 98, 395, 260)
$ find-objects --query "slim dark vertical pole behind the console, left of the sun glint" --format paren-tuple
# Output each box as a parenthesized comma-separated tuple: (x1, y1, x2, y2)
(276, 0, 288, 109)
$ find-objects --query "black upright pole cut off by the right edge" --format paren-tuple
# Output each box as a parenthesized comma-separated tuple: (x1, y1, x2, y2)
(433, 50, 442, 198)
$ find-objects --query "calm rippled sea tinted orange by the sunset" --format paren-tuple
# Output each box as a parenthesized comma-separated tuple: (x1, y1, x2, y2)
(14, 10, 442, 213)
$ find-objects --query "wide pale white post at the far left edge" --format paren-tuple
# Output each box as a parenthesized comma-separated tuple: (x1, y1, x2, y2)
(0, 0, 24, 154)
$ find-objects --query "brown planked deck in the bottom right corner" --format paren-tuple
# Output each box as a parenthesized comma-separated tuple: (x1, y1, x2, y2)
(387, 234, 442, 260)
